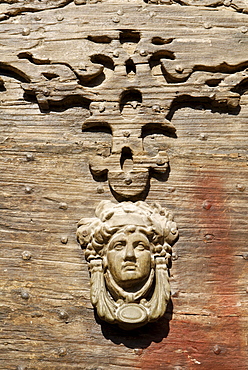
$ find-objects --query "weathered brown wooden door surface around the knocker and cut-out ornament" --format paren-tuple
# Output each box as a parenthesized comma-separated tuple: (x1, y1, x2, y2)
(0, 1, 248, 370)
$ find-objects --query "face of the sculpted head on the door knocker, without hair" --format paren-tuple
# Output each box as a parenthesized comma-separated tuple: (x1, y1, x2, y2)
(106, 229, 151, 289)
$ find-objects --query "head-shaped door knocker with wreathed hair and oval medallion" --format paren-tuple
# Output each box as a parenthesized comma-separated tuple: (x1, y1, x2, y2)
(77, 201, 178, 330)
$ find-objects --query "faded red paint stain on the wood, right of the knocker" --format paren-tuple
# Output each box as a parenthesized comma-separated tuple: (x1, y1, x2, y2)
(140, 172, 248, 370)
